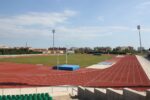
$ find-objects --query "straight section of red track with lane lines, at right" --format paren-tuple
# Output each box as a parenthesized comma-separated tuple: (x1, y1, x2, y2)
(84, 56, 150, 87)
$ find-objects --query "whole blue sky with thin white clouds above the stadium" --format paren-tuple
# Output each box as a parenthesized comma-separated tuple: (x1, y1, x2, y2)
(0, 0, 150, 48)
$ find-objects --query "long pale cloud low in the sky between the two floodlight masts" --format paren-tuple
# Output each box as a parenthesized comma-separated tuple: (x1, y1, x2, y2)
(56, 26, 130, 40)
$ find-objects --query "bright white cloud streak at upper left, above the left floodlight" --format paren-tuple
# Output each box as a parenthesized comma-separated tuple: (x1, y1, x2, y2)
(0, 10, 76, 26)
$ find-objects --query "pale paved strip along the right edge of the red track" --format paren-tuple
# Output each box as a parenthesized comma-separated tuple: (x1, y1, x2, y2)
(136, 55, 150, 80)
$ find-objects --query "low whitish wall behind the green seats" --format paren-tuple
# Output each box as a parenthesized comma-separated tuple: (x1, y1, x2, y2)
(0, 86, 77, 95)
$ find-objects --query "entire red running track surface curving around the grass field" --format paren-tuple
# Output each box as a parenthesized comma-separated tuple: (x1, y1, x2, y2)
(0, 56, 150, 89)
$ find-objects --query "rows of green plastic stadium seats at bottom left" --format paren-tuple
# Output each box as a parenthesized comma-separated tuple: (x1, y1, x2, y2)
(0, 93, 52, 100)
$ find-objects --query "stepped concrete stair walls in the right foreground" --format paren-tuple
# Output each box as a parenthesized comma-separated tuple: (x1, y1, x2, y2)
(78, 86, 150, 100)
